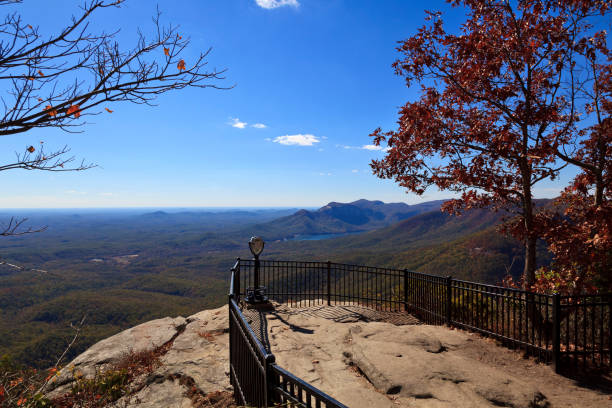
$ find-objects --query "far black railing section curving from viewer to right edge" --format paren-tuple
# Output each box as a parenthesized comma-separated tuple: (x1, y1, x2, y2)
(237, 259, 612, 372)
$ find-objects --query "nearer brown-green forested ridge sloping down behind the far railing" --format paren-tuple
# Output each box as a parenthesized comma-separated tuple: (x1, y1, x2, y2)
(260, 200, 552, 284)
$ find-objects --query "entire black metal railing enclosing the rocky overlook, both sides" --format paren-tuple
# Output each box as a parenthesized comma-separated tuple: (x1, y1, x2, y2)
(229, 259, 612, 408)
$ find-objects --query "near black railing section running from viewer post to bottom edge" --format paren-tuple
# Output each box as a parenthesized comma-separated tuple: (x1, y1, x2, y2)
(229, 261, 348, 408)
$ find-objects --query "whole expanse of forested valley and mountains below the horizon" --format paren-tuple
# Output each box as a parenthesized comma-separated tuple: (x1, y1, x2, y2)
(0, 200, 544, 367)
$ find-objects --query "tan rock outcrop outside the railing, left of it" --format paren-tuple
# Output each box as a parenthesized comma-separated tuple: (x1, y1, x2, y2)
(48, 306, 231, 408)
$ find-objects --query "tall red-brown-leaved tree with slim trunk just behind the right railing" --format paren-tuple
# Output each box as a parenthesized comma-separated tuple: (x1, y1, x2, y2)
(372, 0, 609, 288)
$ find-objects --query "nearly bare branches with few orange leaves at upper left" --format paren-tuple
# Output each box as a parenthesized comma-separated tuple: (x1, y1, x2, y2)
(0, 0, 223, 235)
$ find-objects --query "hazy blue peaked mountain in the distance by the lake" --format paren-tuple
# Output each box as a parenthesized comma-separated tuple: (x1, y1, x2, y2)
(250, 200, 444, 240)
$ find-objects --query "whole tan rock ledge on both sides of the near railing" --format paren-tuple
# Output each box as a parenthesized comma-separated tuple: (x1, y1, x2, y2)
(50, 306, 612, 408)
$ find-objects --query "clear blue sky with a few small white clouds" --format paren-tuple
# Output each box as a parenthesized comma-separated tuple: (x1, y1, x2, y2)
(0, 0, 572, 208)
